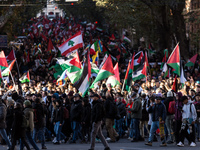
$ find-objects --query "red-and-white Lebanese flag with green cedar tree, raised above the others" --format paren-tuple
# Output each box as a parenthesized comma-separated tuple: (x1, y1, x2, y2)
(59, 31, 84, 56)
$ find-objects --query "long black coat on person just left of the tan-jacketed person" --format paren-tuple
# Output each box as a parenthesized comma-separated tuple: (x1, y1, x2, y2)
(12, 108, 26, 140)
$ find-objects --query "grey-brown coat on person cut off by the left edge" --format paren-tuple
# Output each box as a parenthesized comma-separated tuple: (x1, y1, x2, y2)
(0, 102, 6, 129)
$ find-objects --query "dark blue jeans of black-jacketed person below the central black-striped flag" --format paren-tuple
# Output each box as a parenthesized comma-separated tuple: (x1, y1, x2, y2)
(71, 121, 83, 142)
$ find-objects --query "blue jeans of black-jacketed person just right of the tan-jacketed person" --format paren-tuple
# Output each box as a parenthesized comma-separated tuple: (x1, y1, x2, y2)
(33, 127, 45, 147)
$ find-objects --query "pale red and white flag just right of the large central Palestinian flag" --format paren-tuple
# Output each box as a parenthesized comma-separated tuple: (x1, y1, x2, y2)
(106, 63, 120, 87)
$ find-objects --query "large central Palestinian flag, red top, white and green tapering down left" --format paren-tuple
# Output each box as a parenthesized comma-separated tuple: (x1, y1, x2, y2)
(90, 55, 115, 88)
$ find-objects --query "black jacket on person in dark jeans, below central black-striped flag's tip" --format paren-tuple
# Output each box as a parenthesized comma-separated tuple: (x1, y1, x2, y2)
(70, 100, 83, 122)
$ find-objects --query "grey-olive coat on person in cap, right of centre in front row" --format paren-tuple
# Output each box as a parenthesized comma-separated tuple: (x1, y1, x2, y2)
(128, 98, 142, 119)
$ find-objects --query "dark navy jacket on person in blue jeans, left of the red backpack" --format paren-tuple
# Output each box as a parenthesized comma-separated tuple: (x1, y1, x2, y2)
(148, 102, 167, 121)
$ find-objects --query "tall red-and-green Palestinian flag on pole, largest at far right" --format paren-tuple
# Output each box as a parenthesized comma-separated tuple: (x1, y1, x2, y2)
(167, 44, 180, 76)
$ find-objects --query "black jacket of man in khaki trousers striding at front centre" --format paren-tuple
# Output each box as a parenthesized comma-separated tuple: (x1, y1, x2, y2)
(91, 100, 104, 123)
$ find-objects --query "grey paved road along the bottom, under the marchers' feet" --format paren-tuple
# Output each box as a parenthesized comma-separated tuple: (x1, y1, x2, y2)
(0, 139, 200, 150)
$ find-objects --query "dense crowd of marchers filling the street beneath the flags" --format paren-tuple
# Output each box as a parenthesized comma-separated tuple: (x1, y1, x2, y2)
(0, 14, 200, 150)
